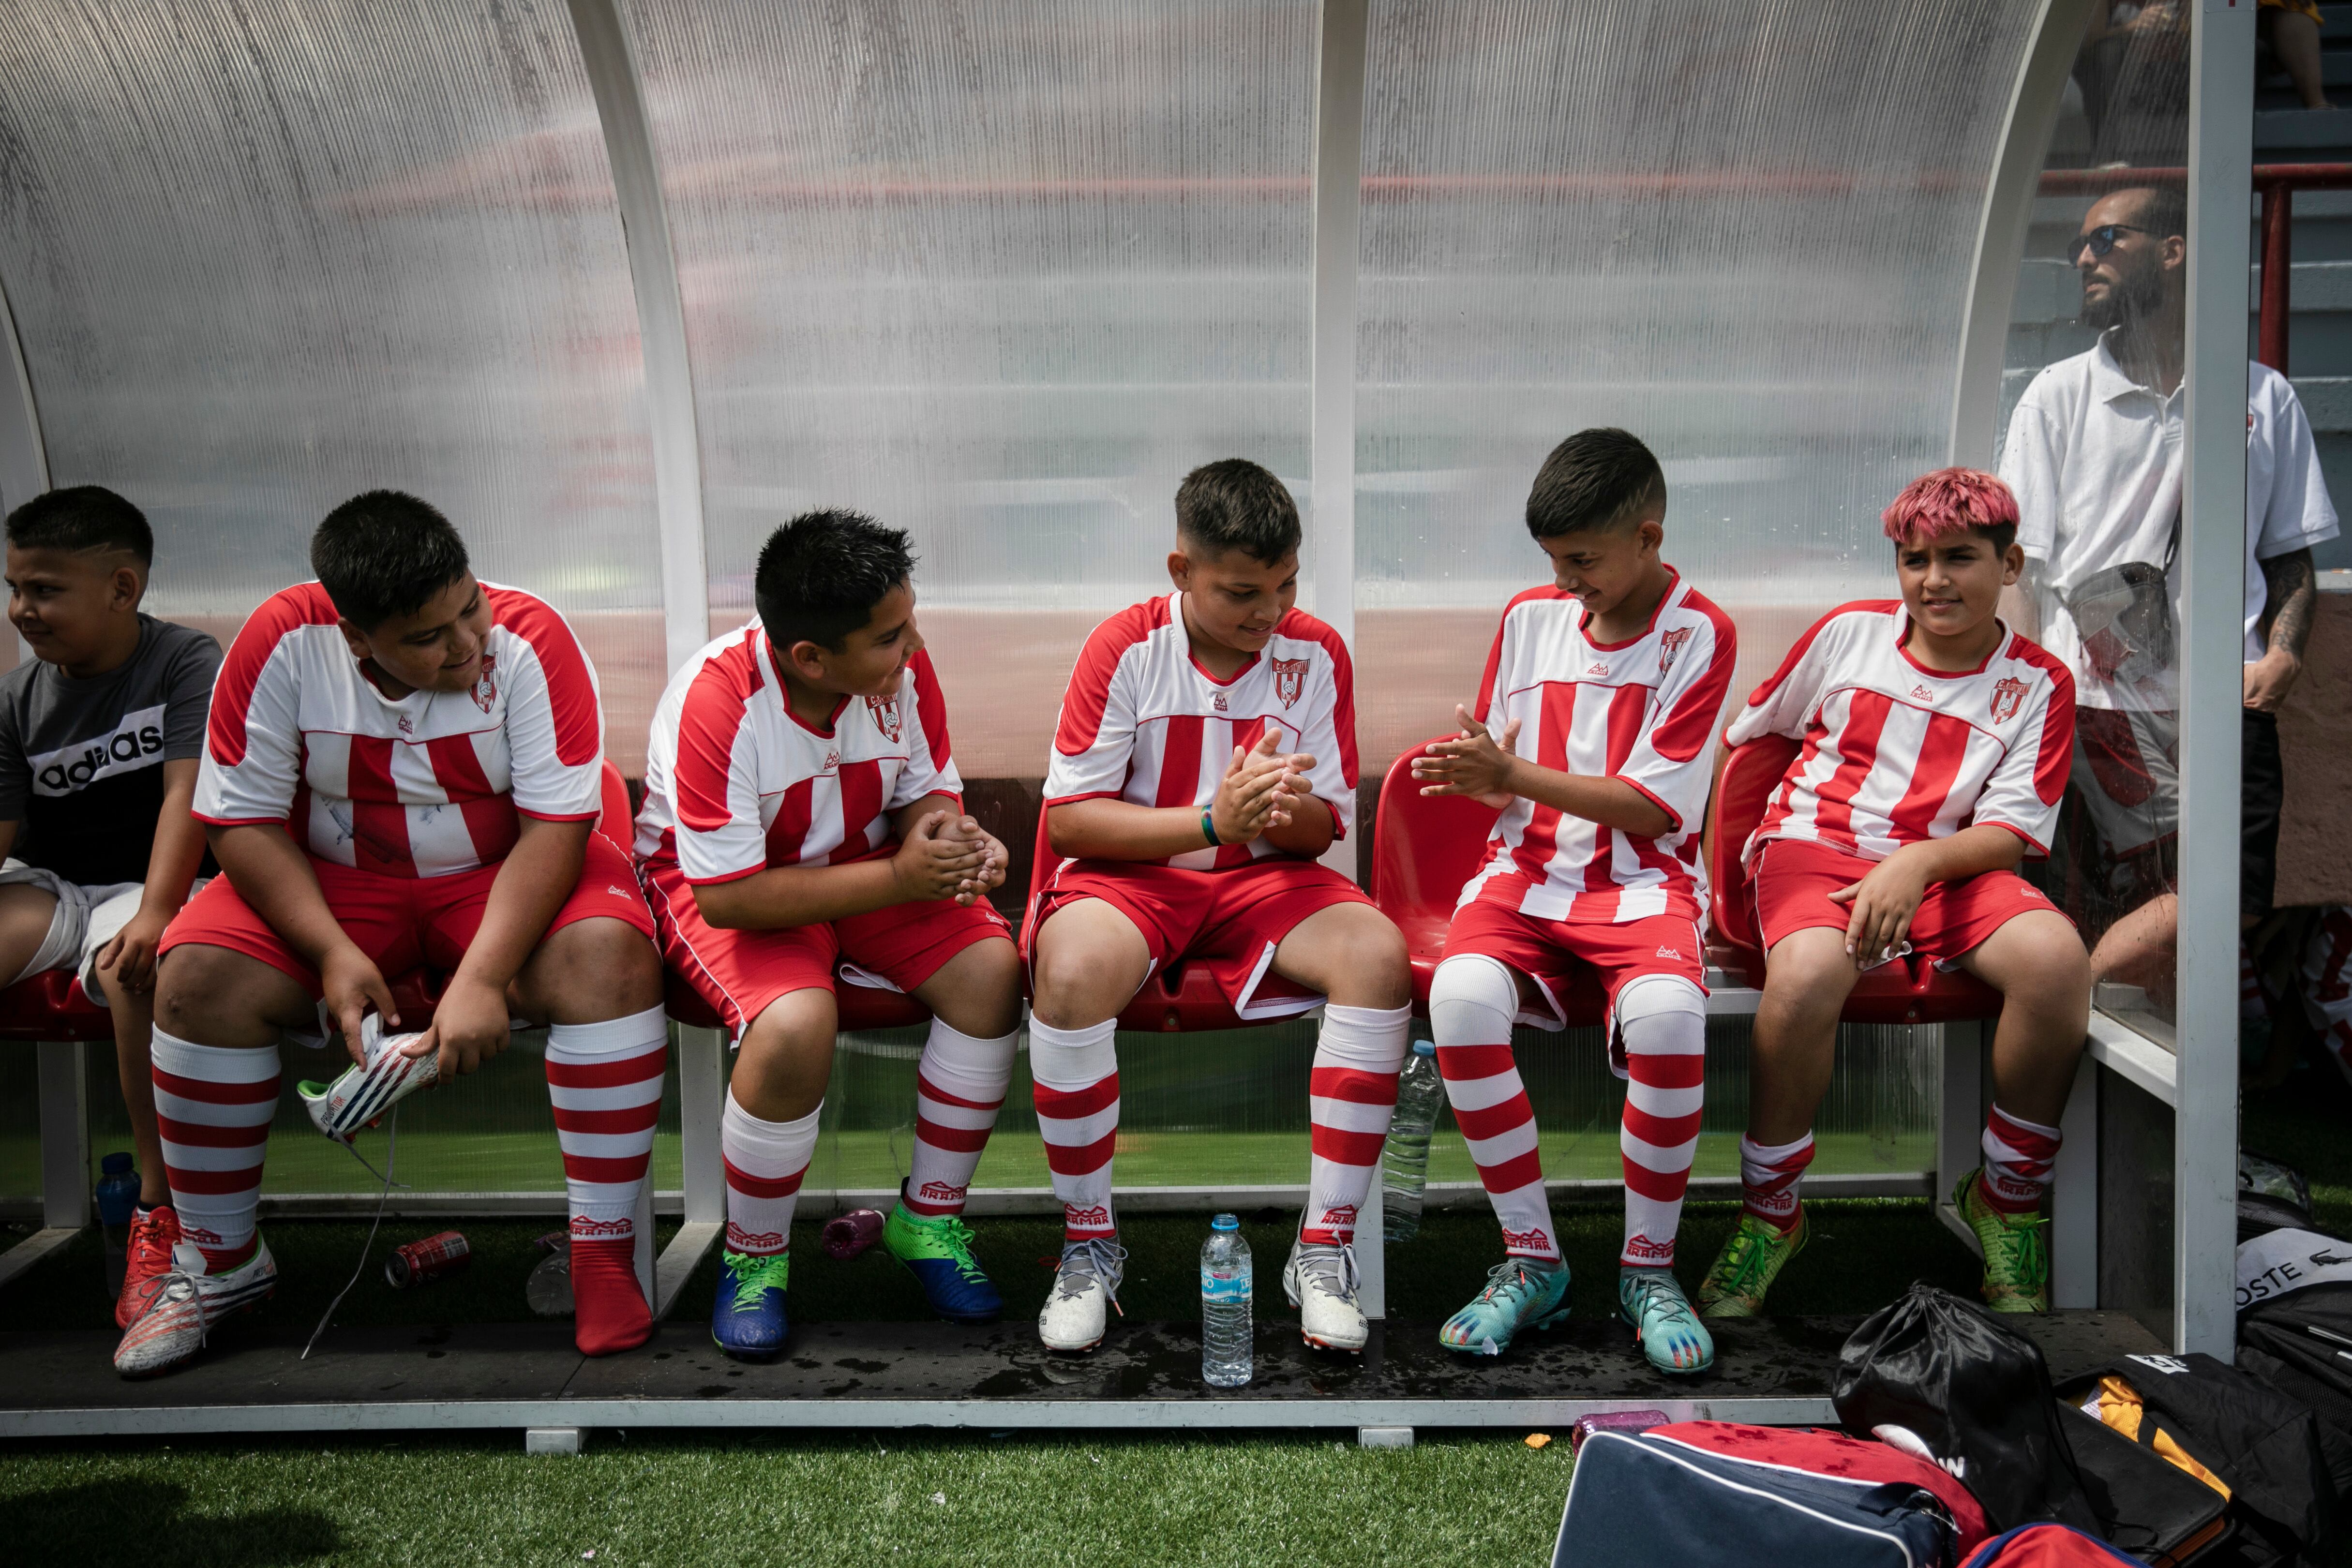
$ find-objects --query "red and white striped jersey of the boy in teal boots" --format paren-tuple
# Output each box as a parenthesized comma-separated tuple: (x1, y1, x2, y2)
(1461, 574, 1738, 924)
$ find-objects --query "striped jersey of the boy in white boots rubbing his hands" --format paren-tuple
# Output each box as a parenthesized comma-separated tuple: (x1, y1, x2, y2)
(1044, 592, 1355, 870)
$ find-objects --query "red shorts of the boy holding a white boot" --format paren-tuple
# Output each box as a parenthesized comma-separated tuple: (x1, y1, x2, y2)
(158, 832, 654, 997)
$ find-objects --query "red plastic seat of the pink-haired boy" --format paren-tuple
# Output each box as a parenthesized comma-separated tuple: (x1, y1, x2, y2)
(1708, 736, 2002, 1023)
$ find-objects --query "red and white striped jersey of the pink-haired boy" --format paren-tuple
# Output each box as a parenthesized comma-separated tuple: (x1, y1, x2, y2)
(1724, 599, 2074, 860)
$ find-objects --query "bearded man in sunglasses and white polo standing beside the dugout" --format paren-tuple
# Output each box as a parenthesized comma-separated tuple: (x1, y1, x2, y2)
(2002, 186, 2336, 1004)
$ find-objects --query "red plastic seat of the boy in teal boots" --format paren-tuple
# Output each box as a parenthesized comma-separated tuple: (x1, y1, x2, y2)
(1371, 736, 1606, 1025)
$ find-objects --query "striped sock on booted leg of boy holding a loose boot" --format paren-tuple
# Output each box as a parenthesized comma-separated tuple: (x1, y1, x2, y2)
(148, 1030, 278, 1274)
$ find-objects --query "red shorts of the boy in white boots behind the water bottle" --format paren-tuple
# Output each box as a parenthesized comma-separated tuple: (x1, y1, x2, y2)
(1025, 856, 1371, 1023)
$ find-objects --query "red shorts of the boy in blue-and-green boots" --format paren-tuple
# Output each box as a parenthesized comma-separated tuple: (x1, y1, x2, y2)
(644, 860, 1014, 1044)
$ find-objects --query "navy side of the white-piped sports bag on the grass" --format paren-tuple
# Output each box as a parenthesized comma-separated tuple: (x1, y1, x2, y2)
(1552, 1432, 1957, 1568)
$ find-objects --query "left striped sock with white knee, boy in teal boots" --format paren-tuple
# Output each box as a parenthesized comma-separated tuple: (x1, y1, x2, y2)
(1430, 955, 1559, 1262)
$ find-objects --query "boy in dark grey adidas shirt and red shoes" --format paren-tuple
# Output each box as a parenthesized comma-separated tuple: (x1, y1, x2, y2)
(0, 484, 221, 1324)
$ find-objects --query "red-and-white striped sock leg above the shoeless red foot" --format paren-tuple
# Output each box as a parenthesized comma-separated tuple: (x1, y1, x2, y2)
(548, 1006, 670, 1246)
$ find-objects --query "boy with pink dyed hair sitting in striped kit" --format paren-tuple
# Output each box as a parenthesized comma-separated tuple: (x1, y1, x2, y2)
(1698, 468, 2091, 1316)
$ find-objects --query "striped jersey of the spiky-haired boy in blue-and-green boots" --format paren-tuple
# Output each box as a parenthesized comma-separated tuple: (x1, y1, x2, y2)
(637, 616, 964, 884)
